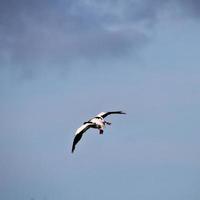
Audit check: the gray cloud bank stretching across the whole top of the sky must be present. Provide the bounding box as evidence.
[0,0,200,72]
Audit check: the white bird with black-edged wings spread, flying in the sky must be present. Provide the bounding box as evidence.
[72,111,126,153]
